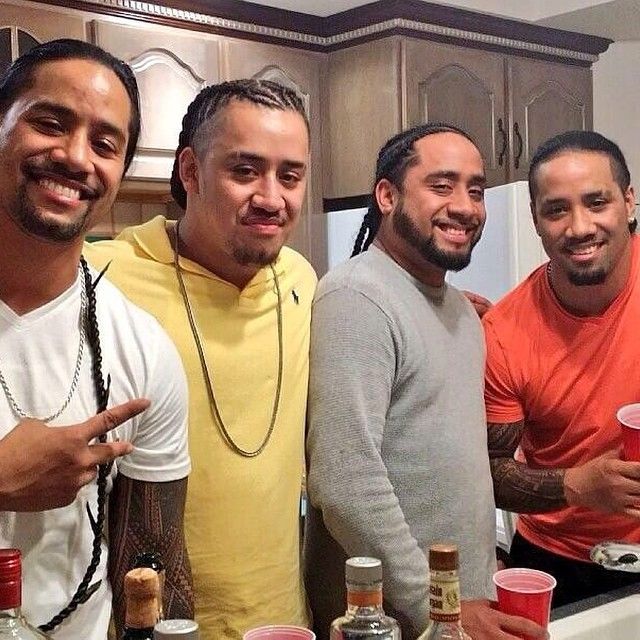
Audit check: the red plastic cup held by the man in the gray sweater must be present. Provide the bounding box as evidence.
[493,569,556,640]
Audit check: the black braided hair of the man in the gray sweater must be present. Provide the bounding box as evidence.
[351,122,476,258]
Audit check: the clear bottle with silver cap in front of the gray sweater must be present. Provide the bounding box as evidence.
[330,558,402,640]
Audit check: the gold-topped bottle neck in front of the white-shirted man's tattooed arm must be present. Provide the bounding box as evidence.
[122,567,160,640]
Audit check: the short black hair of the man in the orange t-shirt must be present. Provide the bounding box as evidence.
[529,131,631,202]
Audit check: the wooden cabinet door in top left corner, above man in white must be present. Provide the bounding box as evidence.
[0,3,86,75]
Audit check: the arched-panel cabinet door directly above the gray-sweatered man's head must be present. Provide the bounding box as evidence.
[404,38,508,186]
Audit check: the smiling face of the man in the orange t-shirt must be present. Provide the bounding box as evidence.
[532,151,635,286]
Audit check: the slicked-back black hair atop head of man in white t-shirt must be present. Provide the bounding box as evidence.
[0,38,140,173]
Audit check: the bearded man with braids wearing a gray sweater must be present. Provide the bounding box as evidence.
[305,124,545,640]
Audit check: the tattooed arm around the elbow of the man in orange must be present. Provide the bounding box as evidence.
[488,420,567,513]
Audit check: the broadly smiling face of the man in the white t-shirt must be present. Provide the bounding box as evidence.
[0,59,131,242]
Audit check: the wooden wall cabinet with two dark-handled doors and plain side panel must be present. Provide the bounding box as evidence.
[325,38,593,199]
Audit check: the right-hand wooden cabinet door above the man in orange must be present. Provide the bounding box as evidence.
[507,57,593,181]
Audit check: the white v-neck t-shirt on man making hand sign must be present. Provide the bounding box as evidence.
[0,272,190,640]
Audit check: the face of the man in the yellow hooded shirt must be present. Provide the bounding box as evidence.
[180,100,309,283]
